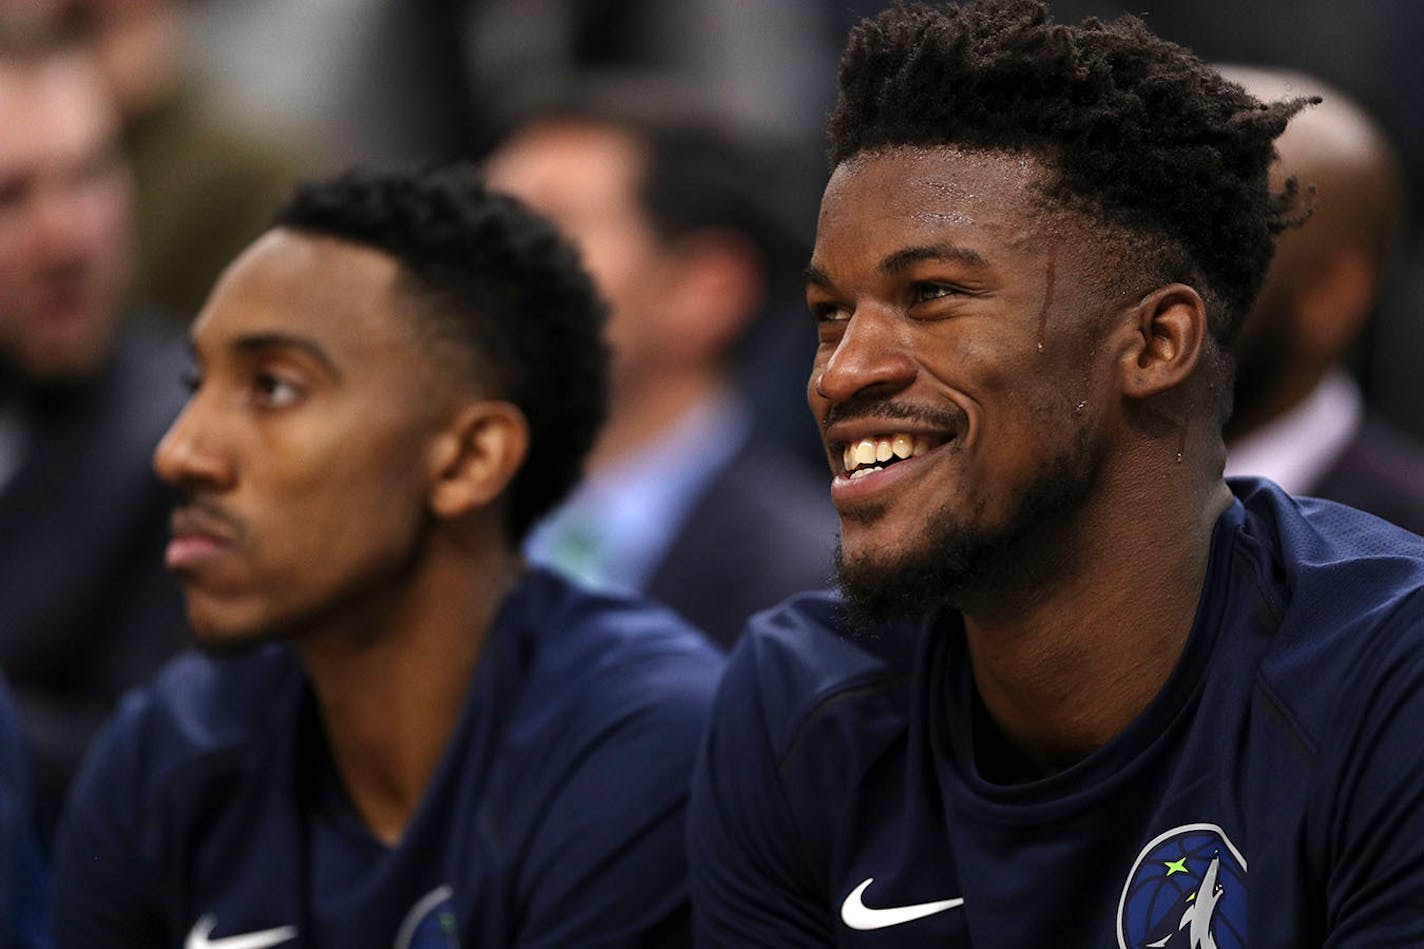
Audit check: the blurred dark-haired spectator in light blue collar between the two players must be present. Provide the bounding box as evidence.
[488,80,834,644]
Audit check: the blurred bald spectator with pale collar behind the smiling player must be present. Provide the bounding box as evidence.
[1222,67,1424,533]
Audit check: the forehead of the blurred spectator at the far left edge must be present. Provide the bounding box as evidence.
[0,53,118,168]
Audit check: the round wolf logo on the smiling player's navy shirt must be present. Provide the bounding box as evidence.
[1118,824,1246,949]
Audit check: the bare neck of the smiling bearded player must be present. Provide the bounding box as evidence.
[963,449,1230,775]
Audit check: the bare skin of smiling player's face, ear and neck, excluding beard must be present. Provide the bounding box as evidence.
[807,148,1230,774]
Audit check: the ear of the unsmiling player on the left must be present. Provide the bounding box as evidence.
[429,402,530,519]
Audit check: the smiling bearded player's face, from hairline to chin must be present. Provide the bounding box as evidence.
[806,148,1111,609]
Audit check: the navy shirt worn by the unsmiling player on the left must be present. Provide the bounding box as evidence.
[54,571,722,949]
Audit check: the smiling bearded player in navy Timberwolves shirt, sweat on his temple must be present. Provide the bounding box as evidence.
[689,0,1424,949]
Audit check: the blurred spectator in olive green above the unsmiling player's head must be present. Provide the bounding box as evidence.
[67,0,303,319]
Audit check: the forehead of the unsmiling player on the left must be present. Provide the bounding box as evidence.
[192,229,414,361]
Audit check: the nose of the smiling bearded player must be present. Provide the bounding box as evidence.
[812,305,916,403]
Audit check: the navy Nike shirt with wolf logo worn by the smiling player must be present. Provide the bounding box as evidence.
[689,480,1424,949]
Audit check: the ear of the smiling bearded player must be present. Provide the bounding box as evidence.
[1118,284,1208,399]
